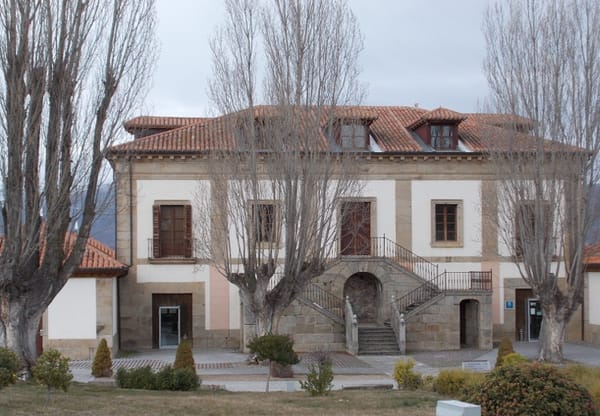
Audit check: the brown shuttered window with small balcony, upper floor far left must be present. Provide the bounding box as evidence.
[151,204,192,258]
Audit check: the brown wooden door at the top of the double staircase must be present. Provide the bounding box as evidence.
[340,201,371,256]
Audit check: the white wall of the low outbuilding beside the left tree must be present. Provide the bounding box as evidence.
[48,278,96,339]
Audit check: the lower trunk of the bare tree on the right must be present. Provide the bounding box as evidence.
[538,308,569,363]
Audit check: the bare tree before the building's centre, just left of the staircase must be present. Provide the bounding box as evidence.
[198,0,367,337]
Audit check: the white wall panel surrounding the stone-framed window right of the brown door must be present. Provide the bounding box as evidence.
[411,180,482,257]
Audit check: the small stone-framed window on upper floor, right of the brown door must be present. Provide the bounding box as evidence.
[431,200,463,247]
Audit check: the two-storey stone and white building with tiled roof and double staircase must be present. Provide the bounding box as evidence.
[108,107,581,352]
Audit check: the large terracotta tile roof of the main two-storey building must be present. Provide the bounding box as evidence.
[109,106,564,156]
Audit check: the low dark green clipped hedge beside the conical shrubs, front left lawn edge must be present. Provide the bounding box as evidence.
[116,366,200,391]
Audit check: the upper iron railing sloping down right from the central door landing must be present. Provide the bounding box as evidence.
[371,235,439,282]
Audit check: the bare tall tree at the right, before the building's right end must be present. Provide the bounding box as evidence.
[484,0,600,362]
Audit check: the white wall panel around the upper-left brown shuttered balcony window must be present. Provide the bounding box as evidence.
[136,179,210,259]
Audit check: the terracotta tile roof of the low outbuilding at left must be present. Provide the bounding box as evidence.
[0,233,128,277]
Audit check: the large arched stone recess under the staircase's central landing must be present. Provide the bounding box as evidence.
[344,273,381,323]
